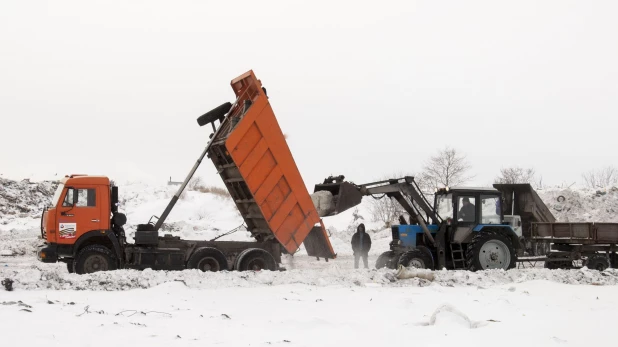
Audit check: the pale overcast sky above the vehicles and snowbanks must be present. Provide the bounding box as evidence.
[0,0,618,191]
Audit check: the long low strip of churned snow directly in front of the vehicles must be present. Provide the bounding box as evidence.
[0,260,618,291]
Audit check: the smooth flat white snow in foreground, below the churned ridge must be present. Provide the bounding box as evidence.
[0,270,618,346]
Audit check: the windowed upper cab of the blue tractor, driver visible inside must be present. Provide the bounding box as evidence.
[434,187,504,227]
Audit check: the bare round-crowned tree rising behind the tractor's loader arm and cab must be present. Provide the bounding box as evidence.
[421,147,474,191]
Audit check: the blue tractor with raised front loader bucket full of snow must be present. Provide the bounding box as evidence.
[314,176,521,271]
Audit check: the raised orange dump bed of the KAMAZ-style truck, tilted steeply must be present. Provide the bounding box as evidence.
[208,71,335,259]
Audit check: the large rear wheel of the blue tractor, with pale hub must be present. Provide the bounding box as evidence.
[466,231,517,271]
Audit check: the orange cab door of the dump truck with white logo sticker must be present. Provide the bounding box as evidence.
[56,186,105,244]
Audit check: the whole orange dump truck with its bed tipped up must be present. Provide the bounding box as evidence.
[38,71,335,274]
